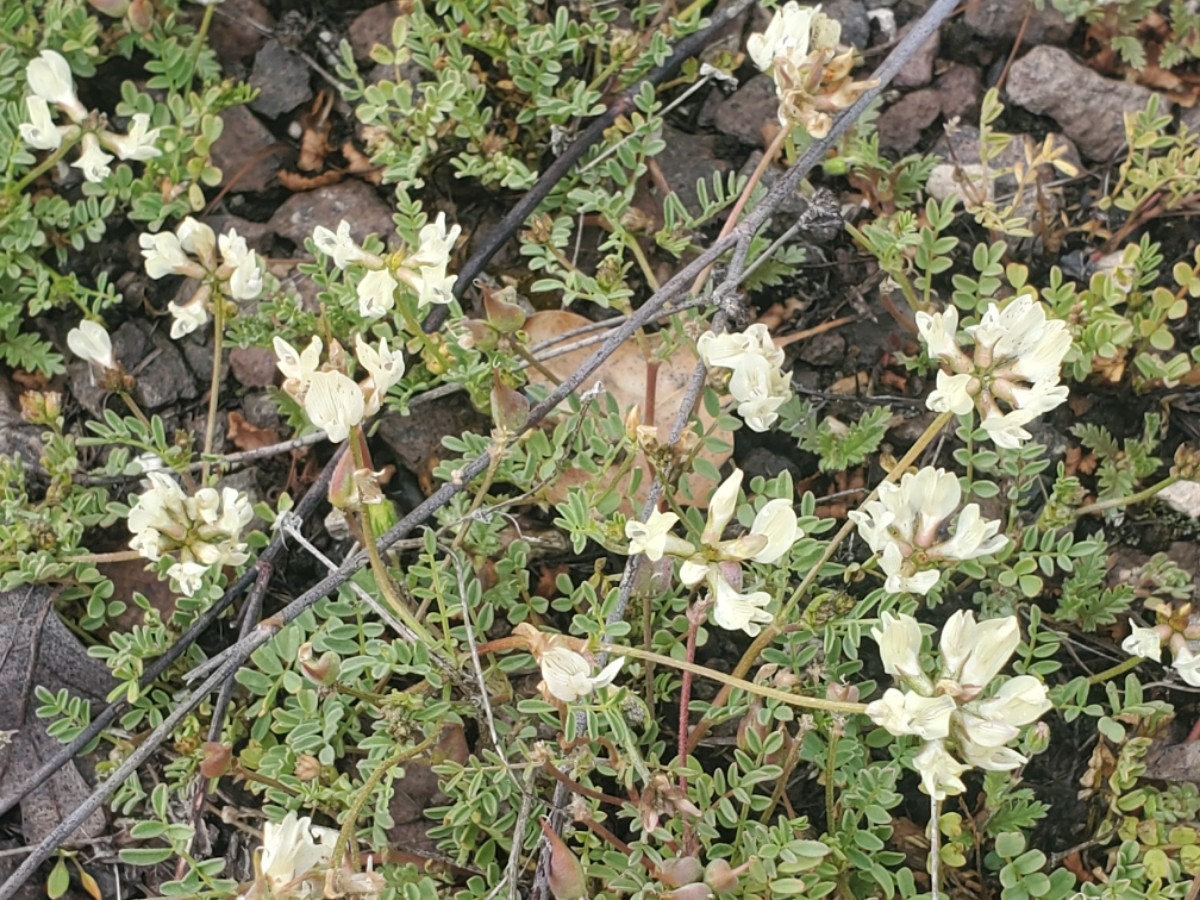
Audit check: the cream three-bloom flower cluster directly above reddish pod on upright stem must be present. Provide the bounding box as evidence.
[275,335,404,443]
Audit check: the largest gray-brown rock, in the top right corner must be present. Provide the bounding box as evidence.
[1008,46,1171,161]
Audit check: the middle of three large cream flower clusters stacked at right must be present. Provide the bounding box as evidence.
[850,466,1008,594]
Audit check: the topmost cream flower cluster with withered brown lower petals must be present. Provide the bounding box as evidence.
[746,0,875,138]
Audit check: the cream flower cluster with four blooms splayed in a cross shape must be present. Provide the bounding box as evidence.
[625,469,803,636]
